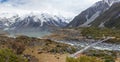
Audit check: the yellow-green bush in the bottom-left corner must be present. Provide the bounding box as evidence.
[0,49,28,62]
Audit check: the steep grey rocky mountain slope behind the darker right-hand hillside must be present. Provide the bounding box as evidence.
[67,0,120,27]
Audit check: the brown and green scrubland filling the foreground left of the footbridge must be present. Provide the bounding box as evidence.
[0,36,77,62]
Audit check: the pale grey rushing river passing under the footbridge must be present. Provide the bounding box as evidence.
[57,40,120,51]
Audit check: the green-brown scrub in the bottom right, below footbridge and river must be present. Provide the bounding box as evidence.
[66,50,120,62]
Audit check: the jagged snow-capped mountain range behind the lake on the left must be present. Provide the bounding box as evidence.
[0,13,70,31]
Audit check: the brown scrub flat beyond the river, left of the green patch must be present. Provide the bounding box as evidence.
[44,29,81,41]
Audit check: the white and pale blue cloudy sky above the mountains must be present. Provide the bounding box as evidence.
[0,0,99,17]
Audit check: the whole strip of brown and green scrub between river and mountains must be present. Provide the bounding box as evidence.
[44,27,120,44]
